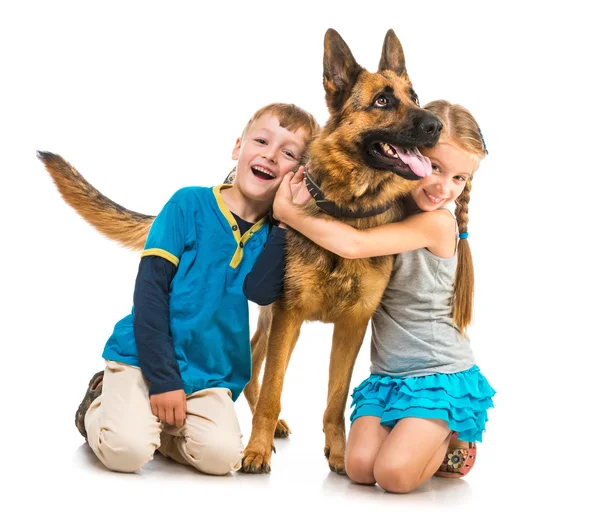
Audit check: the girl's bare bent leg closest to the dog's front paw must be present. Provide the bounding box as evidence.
[346,416,392,484]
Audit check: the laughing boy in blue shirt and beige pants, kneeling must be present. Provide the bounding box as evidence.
[76,104,318,475]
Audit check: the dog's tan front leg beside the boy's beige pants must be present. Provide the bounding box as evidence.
[241,304,303,473]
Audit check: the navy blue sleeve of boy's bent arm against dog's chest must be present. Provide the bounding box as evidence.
[244,226,286,305]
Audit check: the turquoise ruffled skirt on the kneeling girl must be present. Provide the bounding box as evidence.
[350,366,496,442]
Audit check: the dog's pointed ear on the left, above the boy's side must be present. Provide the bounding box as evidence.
[323,28,364,113]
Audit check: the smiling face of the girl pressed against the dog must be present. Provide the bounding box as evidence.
[411,142,477,211]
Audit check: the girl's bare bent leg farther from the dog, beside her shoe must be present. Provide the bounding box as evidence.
[373,417,451,493]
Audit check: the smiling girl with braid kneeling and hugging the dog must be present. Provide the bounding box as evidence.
[274,100,495,493]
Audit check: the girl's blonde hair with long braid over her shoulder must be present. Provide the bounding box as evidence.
[425,100,487,334]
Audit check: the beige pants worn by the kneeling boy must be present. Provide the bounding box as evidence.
[85,361,244,475]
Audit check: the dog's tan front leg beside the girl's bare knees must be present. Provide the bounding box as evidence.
[323,317,369,475]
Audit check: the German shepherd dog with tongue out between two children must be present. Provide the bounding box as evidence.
[38,29,442,474]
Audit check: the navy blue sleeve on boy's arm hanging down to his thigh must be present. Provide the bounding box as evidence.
[133,256,183,395]
